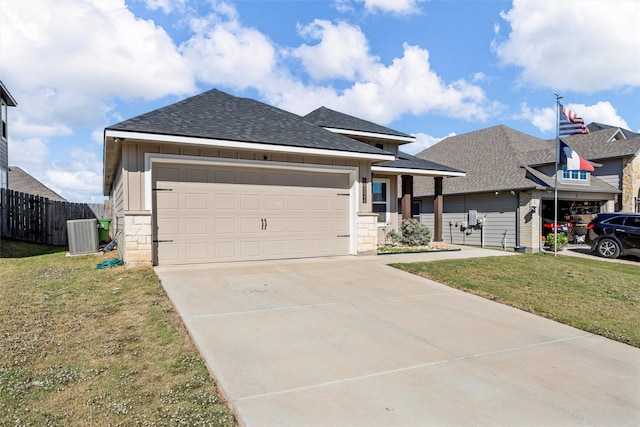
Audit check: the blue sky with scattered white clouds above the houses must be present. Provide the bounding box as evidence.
[0,0,640,202]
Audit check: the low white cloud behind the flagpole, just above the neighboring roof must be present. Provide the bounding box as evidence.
[514,101,629,132]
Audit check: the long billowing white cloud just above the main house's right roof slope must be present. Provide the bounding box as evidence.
[274,37,501,124]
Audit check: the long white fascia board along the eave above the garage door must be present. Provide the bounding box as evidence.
[105,129,395,161]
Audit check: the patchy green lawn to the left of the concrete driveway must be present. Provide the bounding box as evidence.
[0,239,235,426]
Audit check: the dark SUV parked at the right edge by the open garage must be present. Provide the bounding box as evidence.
[585,212,640,258]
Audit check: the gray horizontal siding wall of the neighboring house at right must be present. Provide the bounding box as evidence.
[412,193,517,249]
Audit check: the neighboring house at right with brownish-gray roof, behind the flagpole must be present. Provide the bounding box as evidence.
[414,125,640,252]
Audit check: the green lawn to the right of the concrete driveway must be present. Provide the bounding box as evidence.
[392,254,640,347]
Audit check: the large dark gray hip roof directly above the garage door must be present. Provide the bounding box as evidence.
[106,89,390,155]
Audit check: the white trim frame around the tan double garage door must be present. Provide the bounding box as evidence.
[144,153,360,255]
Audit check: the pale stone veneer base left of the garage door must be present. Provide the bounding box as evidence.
[121,211,152,267]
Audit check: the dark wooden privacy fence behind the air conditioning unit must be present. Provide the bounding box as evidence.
[0,189,104,246]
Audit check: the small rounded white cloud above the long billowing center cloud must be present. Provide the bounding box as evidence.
[291,19,378,80]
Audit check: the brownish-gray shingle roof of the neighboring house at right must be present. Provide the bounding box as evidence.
[414,125,624,196]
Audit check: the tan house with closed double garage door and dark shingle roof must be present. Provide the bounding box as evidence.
[104,90,464,265]
